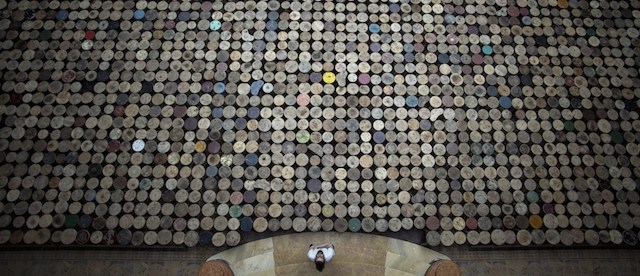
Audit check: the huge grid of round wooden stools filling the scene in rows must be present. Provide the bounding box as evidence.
[0,0,640,246]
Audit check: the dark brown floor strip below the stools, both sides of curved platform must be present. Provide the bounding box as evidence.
[0,236,640,275]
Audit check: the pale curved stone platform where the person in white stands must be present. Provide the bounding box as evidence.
[209,232,450,276]
